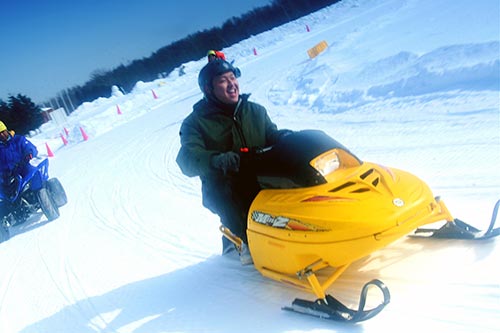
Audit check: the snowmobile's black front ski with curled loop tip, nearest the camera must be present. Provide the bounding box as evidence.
[282,279,391,323]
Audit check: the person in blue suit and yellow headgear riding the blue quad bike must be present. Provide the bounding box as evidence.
[0,121,38,204]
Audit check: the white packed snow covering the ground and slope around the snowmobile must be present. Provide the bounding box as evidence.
[0,0,500,333]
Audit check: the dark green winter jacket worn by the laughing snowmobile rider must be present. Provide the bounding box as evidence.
[176,95,279,208]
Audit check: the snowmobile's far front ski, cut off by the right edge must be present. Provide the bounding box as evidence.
[410,200,500,240]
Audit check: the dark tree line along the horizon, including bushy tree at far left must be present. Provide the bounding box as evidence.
[0,0,341,133]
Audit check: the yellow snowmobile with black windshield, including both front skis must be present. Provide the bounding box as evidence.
[221,130,500,322]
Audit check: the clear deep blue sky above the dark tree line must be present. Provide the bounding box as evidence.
[0,0,271,103]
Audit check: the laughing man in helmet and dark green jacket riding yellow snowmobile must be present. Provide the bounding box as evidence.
[177,59,286,264]
